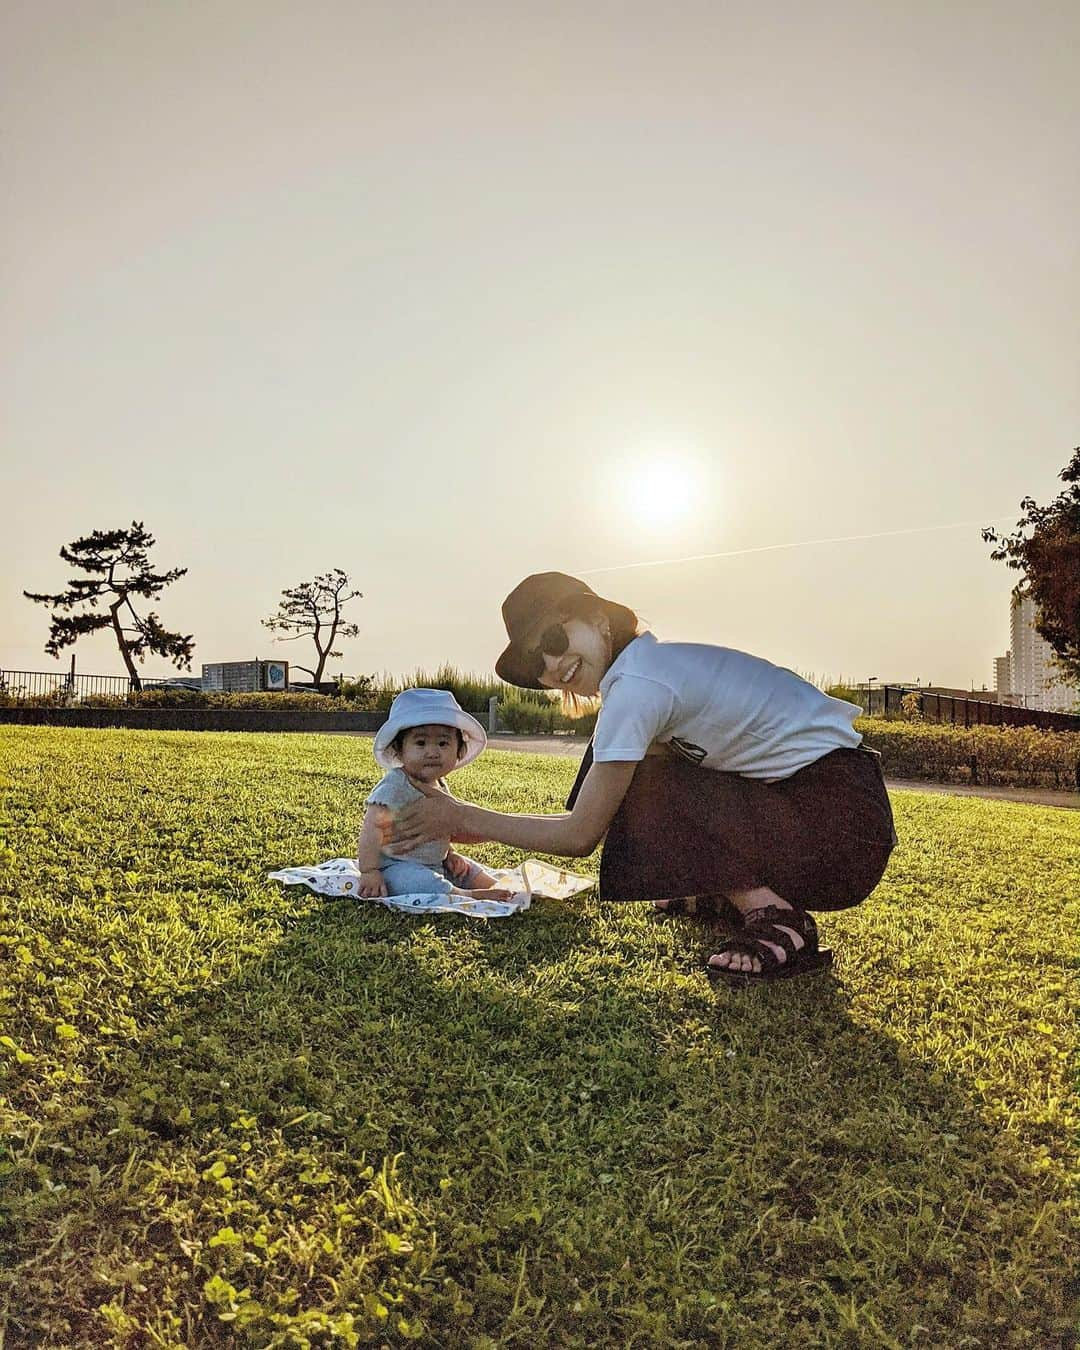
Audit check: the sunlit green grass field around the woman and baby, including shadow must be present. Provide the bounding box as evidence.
[0,728,1080,1350]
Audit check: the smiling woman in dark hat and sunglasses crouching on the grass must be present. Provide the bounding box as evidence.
[394,572,896,984]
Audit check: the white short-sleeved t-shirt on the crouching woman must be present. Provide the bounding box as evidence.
[593,633,863,782]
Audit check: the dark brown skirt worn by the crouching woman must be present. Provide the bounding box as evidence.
[567,747,896,910]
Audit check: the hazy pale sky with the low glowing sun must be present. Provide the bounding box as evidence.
[0,0,1080,689]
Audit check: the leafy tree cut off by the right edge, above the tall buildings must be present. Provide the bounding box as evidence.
[983,446,1080,683]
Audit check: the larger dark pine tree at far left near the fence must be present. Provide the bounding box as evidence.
[23,520,194,689]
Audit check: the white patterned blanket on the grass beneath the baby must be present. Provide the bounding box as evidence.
[267,857,597,919]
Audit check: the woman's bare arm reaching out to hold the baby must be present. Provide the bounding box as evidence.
[394,760,637,857]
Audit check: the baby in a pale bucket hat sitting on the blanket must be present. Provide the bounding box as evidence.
[356,689,512,900]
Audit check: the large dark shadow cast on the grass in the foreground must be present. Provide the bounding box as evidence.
[4,902,1076,1347]
